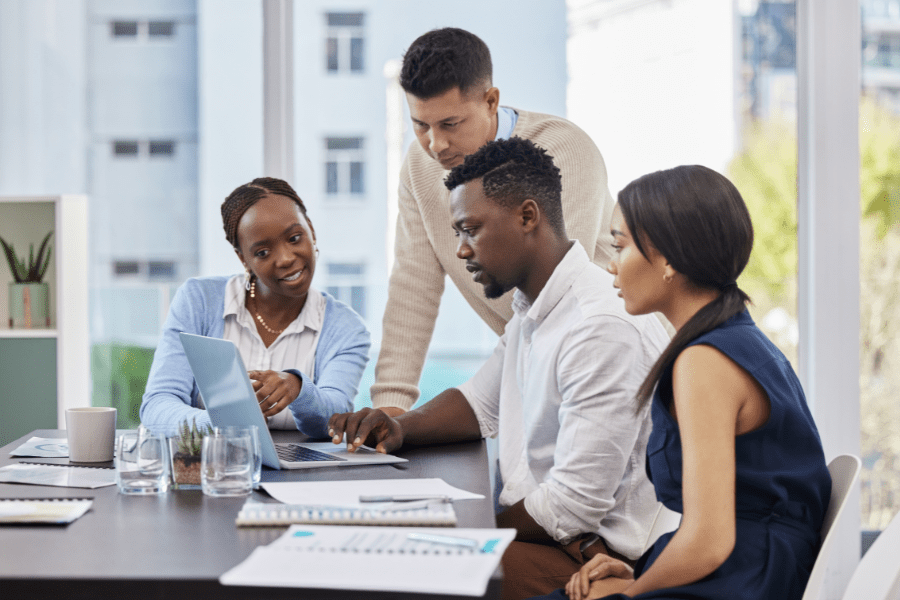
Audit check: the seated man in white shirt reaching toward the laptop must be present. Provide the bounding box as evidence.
[329,137,668,598]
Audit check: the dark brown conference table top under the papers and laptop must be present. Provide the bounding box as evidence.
[0,429,502,600]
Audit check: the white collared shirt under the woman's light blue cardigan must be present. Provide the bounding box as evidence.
[222,275,325,429]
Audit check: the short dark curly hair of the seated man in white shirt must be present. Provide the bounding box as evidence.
[444,137,566,235]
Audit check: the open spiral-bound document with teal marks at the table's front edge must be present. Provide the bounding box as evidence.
[219,525,516,596]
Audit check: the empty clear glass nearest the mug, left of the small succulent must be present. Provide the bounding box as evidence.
[115,425,169,494]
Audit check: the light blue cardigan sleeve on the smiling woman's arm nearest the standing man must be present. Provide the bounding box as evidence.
[287,293,371,438]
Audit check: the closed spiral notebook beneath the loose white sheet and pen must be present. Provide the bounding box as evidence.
[235,500,456,527]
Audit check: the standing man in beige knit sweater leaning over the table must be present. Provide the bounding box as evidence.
[371,28,615,415]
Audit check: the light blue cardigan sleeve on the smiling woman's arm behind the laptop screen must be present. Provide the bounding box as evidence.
[141,278,227,436]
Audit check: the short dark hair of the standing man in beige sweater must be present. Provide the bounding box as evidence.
[400,27,493,99]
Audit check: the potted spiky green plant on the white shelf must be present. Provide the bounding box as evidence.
[0,231,53,329]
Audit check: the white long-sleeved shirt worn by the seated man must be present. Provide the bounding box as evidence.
[459,241,669,558]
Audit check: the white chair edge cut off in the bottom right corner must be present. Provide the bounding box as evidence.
[844,506,900,600]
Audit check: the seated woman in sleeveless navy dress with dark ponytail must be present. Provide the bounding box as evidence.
[540,166,831,600]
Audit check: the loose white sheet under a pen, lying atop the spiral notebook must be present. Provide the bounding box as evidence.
[260,478,484,508]
